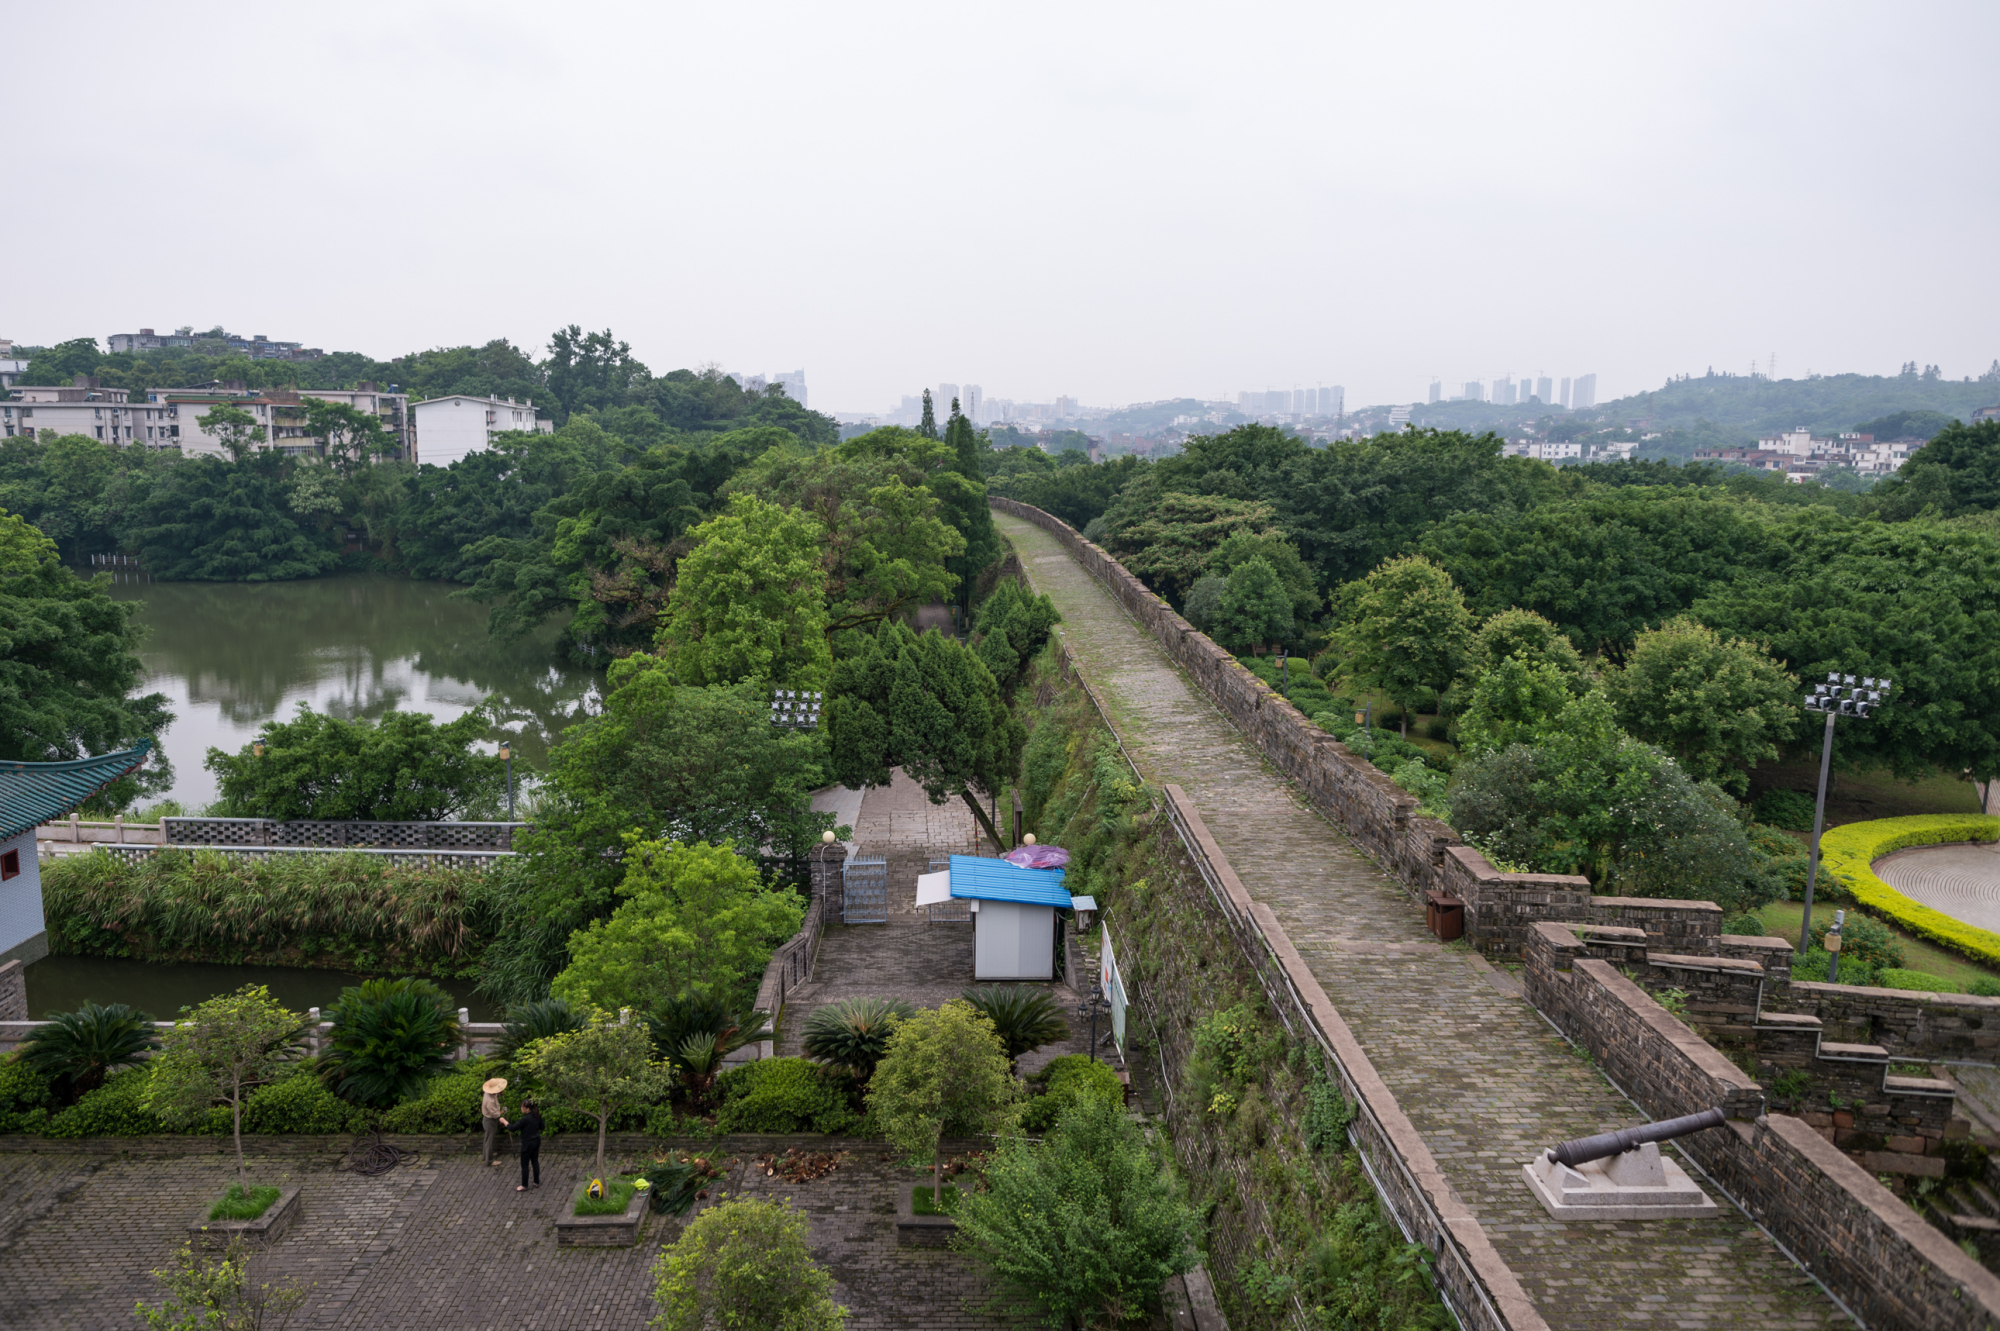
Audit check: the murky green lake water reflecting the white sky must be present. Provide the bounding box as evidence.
[101,570,602,811]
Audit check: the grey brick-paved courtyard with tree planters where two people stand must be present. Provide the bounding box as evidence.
[0,1139,1016,1331]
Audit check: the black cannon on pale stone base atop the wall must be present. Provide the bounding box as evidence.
[1522,1109,1728,1221]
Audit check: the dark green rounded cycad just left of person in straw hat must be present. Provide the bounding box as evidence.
[320,979,458,1107]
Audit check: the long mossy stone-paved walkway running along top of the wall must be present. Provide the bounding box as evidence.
[994,512,1850,1331]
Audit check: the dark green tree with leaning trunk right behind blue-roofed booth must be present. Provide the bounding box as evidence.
[826,624,1028,845]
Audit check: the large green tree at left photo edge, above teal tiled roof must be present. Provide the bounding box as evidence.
[0,510,174,787]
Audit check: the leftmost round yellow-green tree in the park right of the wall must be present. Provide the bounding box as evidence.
[1340,556,1472,739]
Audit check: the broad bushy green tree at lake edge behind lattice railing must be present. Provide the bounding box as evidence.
[204,703,506,821]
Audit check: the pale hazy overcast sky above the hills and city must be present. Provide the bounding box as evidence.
[15,0,2000,410]
